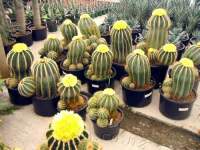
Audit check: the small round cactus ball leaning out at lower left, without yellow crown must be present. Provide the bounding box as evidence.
[18,77,36,97]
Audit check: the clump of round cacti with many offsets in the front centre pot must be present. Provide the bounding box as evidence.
[87,88,120,128]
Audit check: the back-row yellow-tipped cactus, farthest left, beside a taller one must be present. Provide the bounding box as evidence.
[60,19,78,47]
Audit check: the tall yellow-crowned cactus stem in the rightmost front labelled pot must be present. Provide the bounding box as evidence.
[172,58,195,99]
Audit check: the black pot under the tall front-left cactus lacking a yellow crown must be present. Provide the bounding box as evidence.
[32,96,59,116]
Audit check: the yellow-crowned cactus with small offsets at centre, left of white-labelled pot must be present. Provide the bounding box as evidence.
[87,44,113,80]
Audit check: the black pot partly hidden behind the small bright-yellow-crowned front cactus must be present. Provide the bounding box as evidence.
[60,61,87,84]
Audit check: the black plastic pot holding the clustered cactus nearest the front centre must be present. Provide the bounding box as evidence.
[92,109,124,140]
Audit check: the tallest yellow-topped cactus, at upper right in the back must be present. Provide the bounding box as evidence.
[146,8,171,49]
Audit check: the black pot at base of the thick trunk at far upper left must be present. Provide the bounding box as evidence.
[13,29,33,46]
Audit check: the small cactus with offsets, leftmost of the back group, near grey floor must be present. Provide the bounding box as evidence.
[39,34,62,61]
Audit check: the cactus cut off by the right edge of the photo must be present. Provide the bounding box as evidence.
[182,43,200,66]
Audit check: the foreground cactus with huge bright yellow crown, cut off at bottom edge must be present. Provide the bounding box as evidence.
[46,111,89,150]
